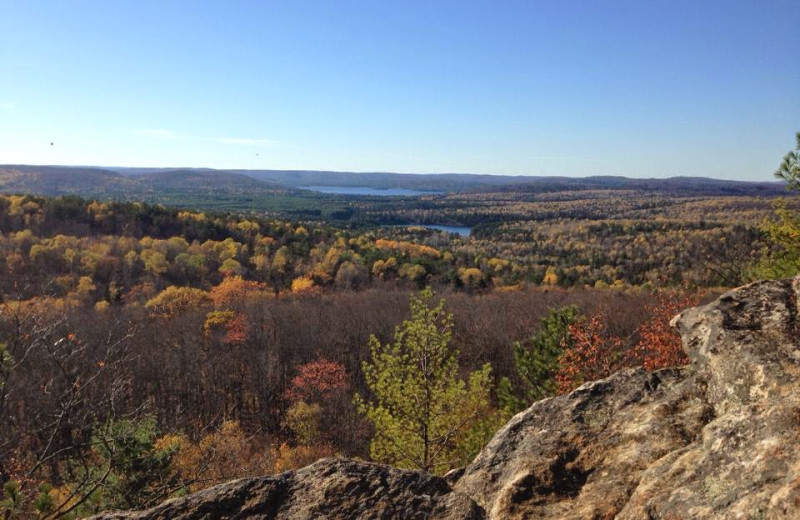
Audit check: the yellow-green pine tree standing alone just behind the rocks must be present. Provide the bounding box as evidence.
[356,289,498,474]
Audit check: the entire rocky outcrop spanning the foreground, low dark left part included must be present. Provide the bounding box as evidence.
[90,279,800,520]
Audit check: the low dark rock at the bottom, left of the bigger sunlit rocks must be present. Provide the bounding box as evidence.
[93,459,484,520]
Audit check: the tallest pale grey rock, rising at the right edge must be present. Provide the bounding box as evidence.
[619,279,800,519]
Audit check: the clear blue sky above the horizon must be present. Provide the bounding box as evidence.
[0,0,800,180]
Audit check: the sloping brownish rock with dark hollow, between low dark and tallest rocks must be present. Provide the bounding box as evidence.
[455,369,712,518]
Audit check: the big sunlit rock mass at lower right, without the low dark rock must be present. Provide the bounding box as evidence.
[455,281,800,520]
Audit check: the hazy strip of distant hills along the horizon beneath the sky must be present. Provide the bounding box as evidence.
[0,165,785,210]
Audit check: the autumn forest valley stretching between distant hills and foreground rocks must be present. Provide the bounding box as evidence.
[0,135,800,518]
